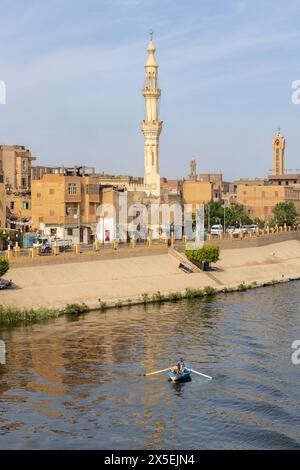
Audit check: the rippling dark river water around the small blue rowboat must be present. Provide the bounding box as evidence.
[0,282,300,450]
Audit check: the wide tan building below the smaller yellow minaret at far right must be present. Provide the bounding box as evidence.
[237,185,300,220]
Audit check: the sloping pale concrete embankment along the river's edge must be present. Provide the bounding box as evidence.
[0,240,300,309]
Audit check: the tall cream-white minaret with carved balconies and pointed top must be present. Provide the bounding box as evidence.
[141,33,162,197]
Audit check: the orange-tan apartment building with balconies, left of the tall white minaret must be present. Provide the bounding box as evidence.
[31,172,101,243]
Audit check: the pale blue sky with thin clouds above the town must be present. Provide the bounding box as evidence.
[0,0,300,179]
